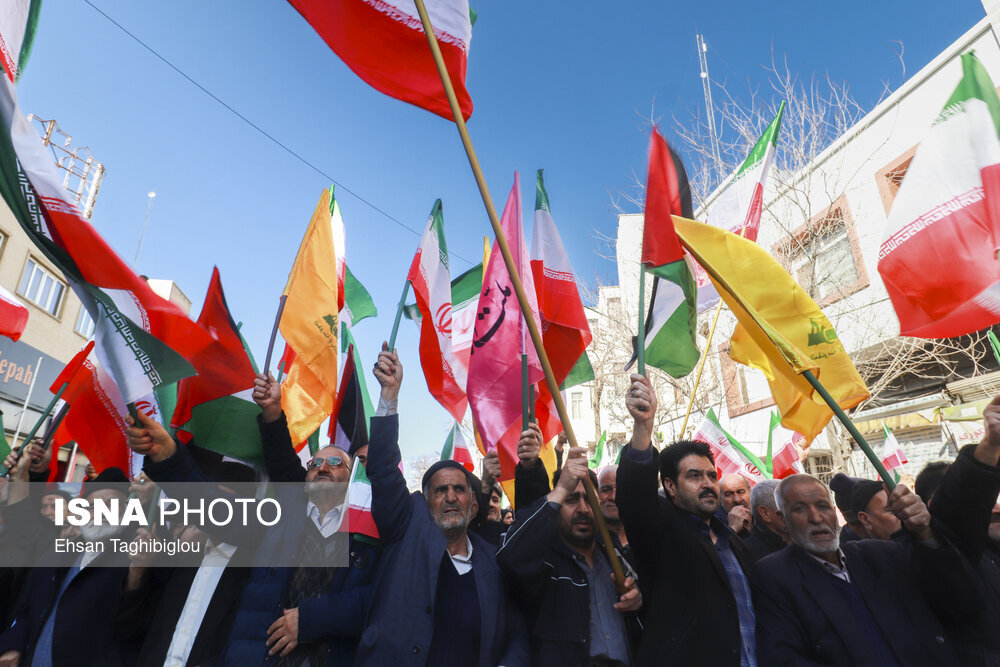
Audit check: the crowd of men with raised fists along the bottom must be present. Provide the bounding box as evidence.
[0,346,1000,667]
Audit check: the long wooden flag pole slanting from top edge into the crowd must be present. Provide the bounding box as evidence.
[414,0,625,595]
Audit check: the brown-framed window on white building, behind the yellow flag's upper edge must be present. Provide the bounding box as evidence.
[776,197,868,306]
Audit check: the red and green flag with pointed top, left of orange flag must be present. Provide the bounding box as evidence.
[170,269,264,466]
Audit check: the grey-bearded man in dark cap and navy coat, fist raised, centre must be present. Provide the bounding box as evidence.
[357,345,528,667]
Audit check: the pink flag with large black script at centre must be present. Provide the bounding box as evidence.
[468,172,543,479]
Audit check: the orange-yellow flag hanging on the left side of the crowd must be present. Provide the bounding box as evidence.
[280,190,337,445]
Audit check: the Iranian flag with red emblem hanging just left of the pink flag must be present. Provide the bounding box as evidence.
[406,199,469,421]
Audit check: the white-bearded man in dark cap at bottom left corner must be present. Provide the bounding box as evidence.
[0,468,128,667]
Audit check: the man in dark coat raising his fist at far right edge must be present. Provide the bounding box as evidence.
[915,397,1000,665]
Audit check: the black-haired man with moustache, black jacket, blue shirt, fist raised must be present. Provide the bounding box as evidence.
[616,375,757,667]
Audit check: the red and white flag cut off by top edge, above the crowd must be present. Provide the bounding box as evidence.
[289,0,472,120]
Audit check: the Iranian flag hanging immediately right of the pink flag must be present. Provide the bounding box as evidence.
[531,169,593,442]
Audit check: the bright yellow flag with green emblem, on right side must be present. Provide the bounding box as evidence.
[674,216,870,442]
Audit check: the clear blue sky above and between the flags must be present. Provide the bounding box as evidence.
[13,0,983,458]
